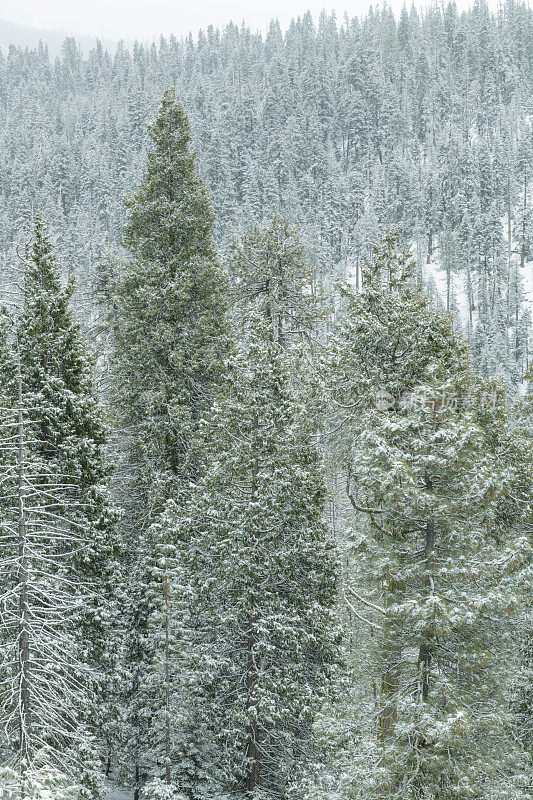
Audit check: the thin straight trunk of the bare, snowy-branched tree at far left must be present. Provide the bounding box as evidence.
[17,356,32,784]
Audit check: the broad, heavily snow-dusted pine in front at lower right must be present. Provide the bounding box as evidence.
[347,372,528,798]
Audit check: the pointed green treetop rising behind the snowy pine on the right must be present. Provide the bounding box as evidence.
[333,232,467,407]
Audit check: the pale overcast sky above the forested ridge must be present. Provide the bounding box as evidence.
[0,0,494,39]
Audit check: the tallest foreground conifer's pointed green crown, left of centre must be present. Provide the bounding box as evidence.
[112,89,227,503]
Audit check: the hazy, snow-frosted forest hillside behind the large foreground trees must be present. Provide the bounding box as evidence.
[0,2,533,386]
